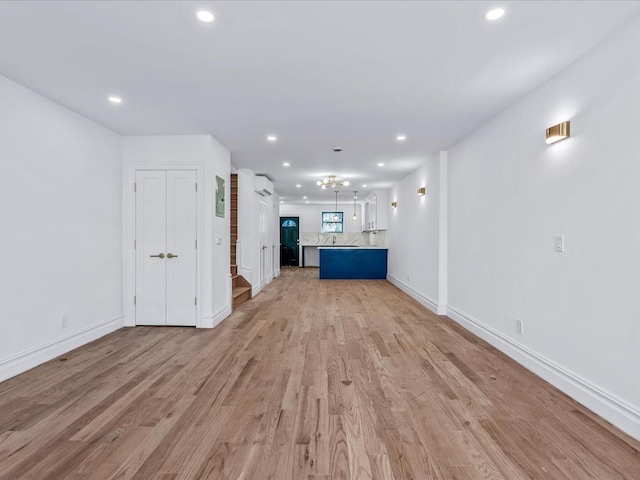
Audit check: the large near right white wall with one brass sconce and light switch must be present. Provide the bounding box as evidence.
[449,18,640,438]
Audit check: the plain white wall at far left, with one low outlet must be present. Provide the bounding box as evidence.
[0,76,123,380]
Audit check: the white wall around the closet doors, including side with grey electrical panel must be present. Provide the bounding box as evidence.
[123,135,231,327]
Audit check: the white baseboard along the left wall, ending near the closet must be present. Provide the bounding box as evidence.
[0,315,124,382]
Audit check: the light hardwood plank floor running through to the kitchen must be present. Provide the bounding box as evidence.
[0,269,640,480]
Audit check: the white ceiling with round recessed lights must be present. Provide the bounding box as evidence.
[0,0,640,203]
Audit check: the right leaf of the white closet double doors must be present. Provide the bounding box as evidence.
[166,171,197,326]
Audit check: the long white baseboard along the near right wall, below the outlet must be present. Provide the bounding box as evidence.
[447,305,640,440]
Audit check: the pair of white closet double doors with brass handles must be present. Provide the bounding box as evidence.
[134,170,197,326]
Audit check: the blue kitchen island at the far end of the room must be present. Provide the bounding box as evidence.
[318,247,388,280]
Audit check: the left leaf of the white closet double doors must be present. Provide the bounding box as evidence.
[136,171,167,325]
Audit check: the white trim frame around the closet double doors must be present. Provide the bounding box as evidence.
[124,164,204,328]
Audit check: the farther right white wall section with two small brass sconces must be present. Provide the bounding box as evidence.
[387,156,440,311]
